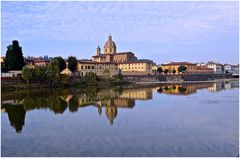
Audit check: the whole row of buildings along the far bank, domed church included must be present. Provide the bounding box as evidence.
[1,35,239,76]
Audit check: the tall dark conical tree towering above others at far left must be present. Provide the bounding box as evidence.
[4,40,25,70]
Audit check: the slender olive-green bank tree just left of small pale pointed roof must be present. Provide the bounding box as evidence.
[48,59,60,87]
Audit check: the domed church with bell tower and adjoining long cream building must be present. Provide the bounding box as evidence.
[77,35,153,76]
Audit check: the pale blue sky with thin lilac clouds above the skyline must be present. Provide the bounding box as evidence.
[1,1,239,64]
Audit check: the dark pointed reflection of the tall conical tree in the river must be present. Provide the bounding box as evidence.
[5,105,26,133]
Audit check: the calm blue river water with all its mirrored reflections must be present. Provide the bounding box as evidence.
[1,81,239,157]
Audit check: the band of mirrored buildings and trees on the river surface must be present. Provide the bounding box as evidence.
[1,81,239,133]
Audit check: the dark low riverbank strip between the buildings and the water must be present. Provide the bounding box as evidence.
[1,76,239,92]
